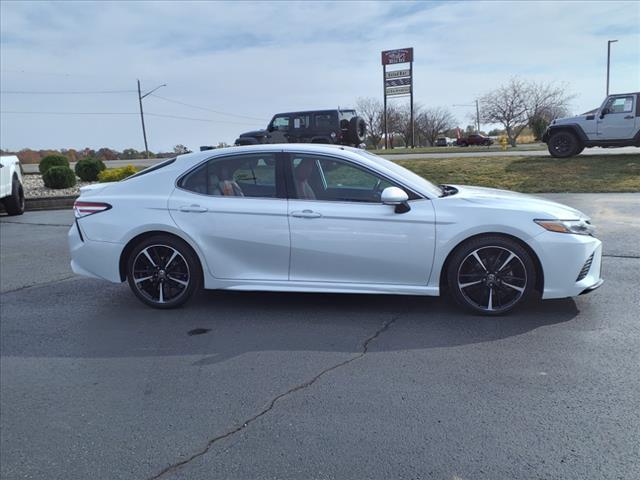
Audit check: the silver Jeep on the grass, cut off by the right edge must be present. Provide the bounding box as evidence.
[542,92,640,158]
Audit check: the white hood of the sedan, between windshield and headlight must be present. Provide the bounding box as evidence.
[445,185,589,220]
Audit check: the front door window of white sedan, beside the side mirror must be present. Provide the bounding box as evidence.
[291,154,395,203]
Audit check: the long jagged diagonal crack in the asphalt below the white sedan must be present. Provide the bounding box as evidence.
[149,315,401,480]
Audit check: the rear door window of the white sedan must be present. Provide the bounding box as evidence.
[178,153,277,198]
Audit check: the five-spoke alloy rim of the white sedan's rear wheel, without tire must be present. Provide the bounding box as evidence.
[132,245,191,304]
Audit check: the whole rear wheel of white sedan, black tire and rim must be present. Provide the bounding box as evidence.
[127,235,202,309]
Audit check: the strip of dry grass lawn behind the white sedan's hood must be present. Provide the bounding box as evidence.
[397,153,640,193]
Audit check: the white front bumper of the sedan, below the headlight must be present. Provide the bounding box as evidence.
[531,232,603,299]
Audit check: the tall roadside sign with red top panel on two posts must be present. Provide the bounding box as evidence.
[382,48,415,149]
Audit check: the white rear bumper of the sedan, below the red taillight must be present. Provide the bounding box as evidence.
[67,223,124,283]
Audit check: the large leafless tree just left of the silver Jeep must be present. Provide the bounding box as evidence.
[480,78,572,147]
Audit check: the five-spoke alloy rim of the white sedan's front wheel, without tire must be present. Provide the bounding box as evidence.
[457,246,527,313]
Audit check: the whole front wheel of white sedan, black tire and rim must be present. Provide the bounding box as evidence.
[446,235,536,316]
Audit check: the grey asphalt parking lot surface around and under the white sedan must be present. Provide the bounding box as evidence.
[0,194,640,480]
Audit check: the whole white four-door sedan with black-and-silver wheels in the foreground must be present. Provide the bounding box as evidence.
[69,144,602,315]
